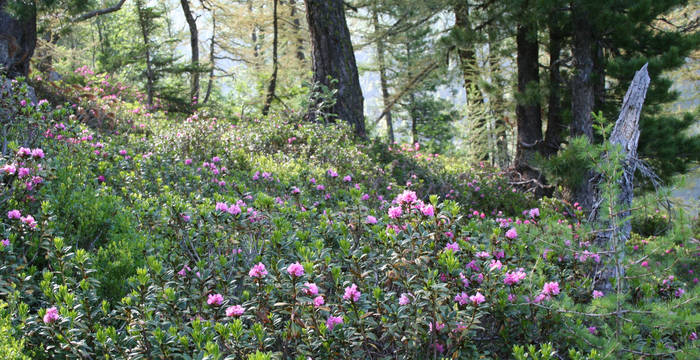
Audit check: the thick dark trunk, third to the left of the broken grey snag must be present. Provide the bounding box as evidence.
[515,23,542,188]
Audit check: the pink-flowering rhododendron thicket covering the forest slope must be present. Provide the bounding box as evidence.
[0,79,700,359]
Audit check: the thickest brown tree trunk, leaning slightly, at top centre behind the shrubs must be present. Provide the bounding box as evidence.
[304,0,365,137]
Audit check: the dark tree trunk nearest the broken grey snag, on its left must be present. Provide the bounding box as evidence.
[571,1,595,210]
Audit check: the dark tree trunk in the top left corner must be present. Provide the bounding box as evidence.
[0,0,36,78]
